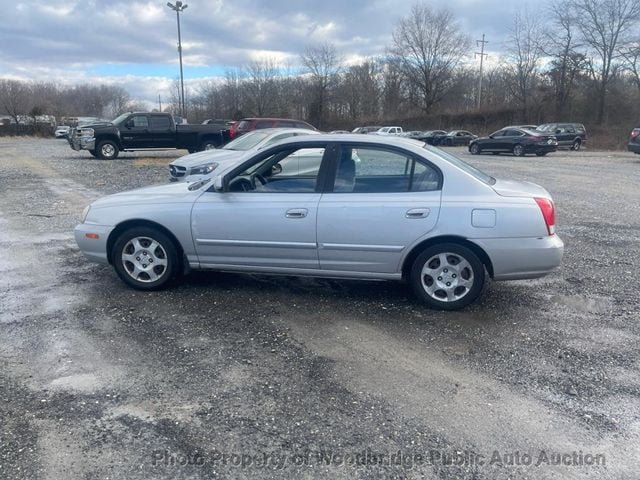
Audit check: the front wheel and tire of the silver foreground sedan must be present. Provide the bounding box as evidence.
[111,227,180,290]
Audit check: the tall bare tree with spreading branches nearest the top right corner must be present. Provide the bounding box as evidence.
[572,0,640,124]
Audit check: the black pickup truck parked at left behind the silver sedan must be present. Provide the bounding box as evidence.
[68,112,229,160]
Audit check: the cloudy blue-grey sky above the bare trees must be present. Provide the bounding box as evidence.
[0,0,522,102]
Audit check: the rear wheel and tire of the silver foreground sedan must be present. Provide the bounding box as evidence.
[410,243,485,310]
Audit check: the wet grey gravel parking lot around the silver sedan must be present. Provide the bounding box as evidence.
[0,138,640,480]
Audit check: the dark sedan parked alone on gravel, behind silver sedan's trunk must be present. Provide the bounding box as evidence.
[469,128,558,157]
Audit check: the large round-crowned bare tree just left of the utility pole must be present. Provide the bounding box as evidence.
[390,3,470,113]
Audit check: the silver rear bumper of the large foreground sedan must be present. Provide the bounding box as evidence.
[471,235,564,280]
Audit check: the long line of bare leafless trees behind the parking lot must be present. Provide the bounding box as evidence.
[0,0,640,139]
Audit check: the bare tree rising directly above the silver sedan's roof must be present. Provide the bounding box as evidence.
[301,43,342,128]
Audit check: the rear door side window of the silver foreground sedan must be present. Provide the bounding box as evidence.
[333,146,440,193]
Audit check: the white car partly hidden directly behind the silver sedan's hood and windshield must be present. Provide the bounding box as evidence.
[169,128,320,182]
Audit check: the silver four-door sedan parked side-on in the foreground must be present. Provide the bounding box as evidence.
[75,135,563,310]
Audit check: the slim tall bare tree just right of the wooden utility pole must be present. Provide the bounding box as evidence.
[504,11,545,122]
